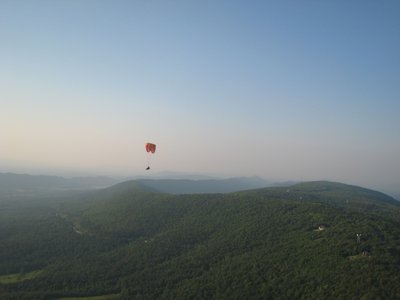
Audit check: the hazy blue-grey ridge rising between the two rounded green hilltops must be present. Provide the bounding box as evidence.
[137,176,272,194]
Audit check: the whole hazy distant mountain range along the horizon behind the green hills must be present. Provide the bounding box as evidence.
[0,173,282,196]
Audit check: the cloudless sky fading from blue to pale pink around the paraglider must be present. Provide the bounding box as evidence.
[0,0,400,190]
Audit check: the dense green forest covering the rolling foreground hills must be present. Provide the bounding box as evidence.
[0,181,400,299]
